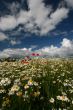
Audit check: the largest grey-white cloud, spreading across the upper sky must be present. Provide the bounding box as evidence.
[0,0,69,35]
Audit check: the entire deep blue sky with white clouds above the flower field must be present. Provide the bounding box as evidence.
[0,0,73,58]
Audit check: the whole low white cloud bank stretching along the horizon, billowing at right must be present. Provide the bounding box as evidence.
[0,38,73,58]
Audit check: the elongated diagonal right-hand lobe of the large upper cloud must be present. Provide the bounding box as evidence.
[41,7,69,34]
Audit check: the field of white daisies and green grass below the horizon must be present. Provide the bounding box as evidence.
[0,58,73,110]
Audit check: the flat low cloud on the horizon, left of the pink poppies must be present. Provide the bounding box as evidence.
[0,48,31,58]
